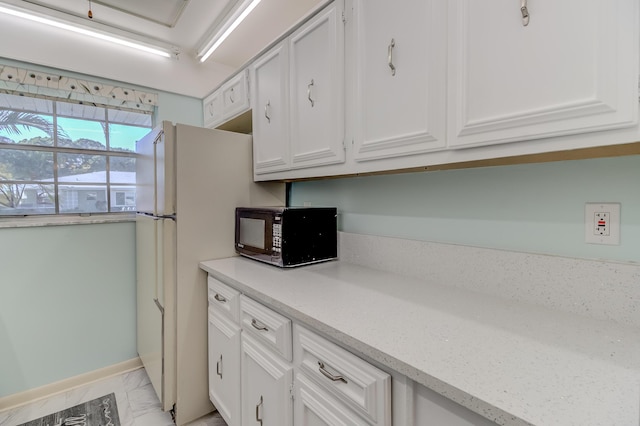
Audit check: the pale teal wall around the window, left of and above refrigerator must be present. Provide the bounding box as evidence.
[0,59,203,400]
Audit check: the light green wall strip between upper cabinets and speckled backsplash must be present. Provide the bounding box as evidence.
[291,156,640,262]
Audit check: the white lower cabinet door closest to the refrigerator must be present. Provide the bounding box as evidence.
[209,309,240,425]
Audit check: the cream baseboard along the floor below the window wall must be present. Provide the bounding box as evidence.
[0,357,142,412]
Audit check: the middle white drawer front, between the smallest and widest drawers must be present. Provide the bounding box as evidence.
[240,295,292,361]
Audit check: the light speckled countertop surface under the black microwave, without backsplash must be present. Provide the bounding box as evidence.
[200,257,640,426]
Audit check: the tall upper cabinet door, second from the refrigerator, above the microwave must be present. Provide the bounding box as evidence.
[289,0,345,168]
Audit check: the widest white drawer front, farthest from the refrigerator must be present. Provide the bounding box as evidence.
[293,324,391,425]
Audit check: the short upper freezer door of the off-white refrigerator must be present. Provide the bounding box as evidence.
[136,122,176,216]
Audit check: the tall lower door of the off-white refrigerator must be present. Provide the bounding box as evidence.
[136,214,175,410]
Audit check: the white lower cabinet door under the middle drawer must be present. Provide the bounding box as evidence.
[242,333,293,426]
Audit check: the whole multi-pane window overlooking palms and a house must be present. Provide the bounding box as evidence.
[0,94,151,216]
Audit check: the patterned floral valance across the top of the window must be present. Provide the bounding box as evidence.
[0,64,158,112]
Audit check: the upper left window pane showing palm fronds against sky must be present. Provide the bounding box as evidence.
[0,109,53,146]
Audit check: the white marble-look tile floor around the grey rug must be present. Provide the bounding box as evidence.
[0,368,227,426]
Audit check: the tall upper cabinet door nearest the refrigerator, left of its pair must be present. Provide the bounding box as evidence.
[251,43,290,174]
